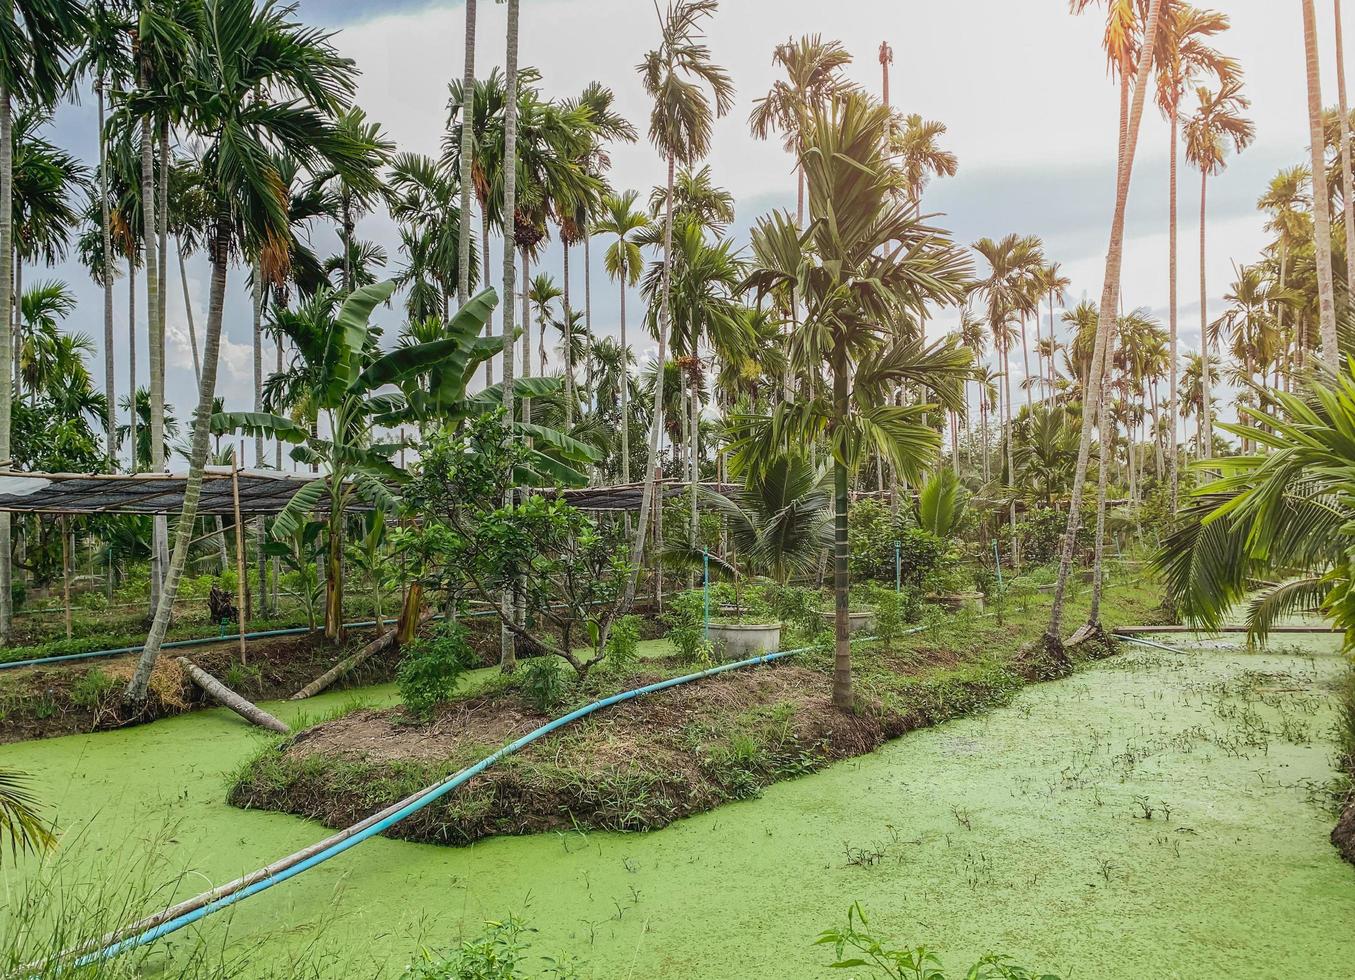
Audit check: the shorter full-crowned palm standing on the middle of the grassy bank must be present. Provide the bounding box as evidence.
[733,94,970,709]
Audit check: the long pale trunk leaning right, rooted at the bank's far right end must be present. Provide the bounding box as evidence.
[1043,0,1163,655]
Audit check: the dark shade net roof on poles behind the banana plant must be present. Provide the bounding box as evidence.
[0,466,737,516]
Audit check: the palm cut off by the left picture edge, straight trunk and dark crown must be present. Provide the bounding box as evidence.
[0,0,83,642]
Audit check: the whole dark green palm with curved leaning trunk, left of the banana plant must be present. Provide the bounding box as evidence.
[127,0,374,702]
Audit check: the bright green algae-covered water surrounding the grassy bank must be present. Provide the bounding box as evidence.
[0,637,1355,979]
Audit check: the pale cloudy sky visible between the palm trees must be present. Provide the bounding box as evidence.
[39,0,1336,460]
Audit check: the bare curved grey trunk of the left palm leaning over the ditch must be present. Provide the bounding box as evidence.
[126,212,234,702]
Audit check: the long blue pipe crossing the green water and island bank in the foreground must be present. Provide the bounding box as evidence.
[75,626,888,968]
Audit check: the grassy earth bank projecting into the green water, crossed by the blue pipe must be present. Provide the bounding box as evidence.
[229,581,1156,844]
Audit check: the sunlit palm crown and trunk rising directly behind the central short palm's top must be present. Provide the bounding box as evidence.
[748,34,855,226]
